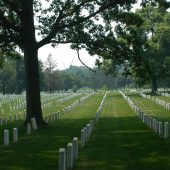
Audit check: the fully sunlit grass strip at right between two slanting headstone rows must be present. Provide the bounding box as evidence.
[126,93,170,122]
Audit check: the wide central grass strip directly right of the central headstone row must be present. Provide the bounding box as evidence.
[74,94,170,170]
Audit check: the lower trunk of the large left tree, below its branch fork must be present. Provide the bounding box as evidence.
[24,47,45,125]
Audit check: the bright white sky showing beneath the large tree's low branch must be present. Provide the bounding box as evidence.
[38,2,140,70]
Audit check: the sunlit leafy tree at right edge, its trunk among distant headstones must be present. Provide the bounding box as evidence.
[127,5,170,94]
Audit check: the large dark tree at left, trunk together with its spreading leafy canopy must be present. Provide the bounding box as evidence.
[0,0,167,124]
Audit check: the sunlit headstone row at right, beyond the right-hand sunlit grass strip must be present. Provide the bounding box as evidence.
[139,92,170,110]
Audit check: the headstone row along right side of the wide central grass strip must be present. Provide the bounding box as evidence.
[120,91,169,138]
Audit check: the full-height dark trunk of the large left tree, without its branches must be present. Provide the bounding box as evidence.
[21,0,46,125]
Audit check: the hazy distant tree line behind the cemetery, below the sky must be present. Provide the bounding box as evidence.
[0,55,132,94]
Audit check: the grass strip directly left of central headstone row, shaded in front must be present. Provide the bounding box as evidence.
[0,94,104,170]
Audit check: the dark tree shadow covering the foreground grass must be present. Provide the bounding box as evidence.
[0,116,170,170]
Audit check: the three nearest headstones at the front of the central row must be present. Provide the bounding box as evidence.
[59,137,78,170]
